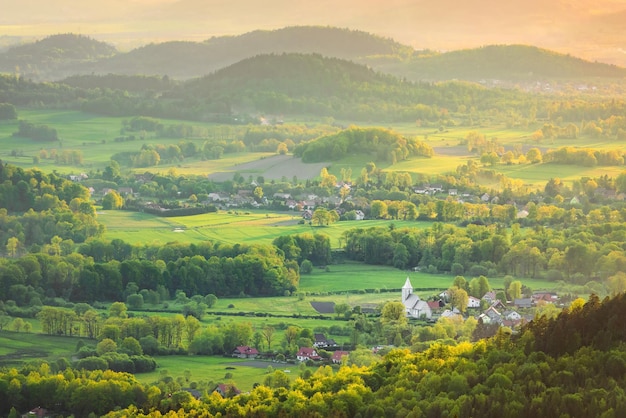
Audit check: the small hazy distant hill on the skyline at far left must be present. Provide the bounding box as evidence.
[0,34,117,80]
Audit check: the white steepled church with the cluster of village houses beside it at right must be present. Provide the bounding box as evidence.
[402,277,559,328]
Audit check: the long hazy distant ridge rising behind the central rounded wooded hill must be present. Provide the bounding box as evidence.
[90,26,413,79]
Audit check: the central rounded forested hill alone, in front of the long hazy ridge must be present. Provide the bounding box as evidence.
[171,54,524,121]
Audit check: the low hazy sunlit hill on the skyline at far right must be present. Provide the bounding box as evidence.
[389,45,626,80]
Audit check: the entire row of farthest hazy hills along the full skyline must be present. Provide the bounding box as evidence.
[0,26,626,85]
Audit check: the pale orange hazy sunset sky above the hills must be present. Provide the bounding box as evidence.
[0,0,626,66]
